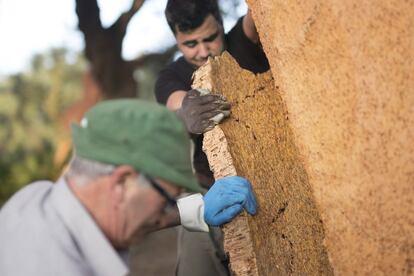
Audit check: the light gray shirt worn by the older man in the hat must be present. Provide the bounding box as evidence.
[0,178,128,276]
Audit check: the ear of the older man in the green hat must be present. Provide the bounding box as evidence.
[109,165,137,204]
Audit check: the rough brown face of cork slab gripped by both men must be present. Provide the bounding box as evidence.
[194,53,332,275]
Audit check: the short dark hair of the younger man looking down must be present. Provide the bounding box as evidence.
[165,0,223,34]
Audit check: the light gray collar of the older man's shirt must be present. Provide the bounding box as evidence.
[51,177,129,275]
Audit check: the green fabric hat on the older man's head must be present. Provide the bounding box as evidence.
[72,99,201,192]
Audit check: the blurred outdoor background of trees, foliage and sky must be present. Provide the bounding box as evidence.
[0,0,247,206]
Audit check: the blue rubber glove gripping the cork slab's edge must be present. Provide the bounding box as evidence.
[204,176,257,226]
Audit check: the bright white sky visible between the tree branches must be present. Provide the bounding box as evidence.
[0,0,247,77]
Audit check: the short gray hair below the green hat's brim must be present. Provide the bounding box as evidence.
[66,155,116,186]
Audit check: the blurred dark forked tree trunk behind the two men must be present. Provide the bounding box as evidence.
[76,0,144,99]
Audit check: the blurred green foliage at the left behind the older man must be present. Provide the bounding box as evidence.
[0,49,85,206]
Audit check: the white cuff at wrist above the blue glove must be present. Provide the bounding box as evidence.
[177,194,209,232]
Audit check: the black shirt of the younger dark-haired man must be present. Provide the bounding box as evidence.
[155,18,269,187]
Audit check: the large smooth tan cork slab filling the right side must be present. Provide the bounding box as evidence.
[247,0,414,275]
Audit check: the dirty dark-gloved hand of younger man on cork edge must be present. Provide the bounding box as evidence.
[177,89,230,134]
